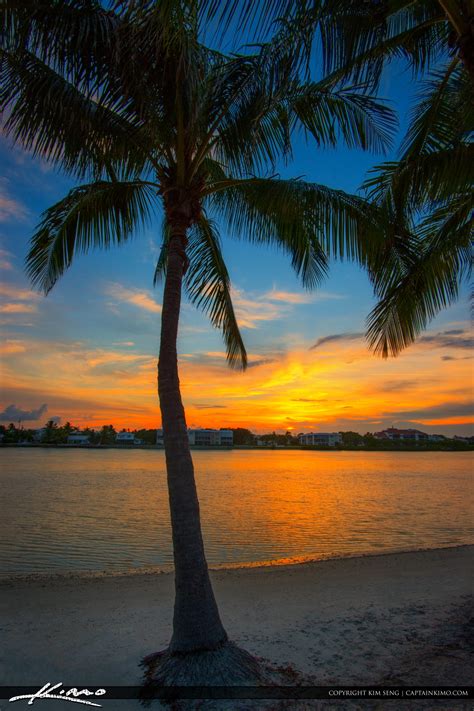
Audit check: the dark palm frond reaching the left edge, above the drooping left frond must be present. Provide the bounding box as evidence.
[0,50,147,177]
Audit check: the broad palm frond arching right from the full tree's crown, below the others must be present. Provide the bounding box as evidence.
[209,178,380,288]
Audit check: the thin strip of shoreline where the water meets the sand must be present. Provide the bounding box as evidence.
[0,541,474,589]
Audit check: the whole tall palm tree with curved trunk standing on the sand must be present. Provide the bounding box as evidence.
[1,0,394,683]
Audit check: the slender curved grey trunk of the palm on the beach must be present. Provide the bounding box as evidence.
[158,223,227,653]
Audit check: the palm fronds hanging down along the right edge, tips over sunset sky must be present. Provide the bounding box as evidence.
[365,62,474,357]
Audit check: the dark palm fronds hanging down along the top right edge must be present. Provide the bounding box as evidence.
[207,0,474,84]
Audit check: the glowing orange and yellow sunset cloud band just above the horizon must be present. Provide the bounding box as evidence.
[2,324,472,432]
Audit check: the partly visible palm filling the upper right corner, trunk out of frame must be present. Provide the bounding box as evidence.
[209,0,474,357]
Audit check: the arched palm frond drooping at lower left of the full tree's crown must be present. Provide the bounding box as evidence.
[26,181,156,293]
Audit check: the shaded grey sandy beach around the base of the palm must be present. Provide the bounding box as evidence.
[0,546,474,710]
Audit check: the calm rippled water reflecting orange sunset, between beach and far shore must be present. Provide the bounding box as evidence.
[0,449,474,573]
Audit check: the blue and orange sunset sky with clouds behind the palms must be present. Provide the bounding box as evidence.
[0,54,473,436]
